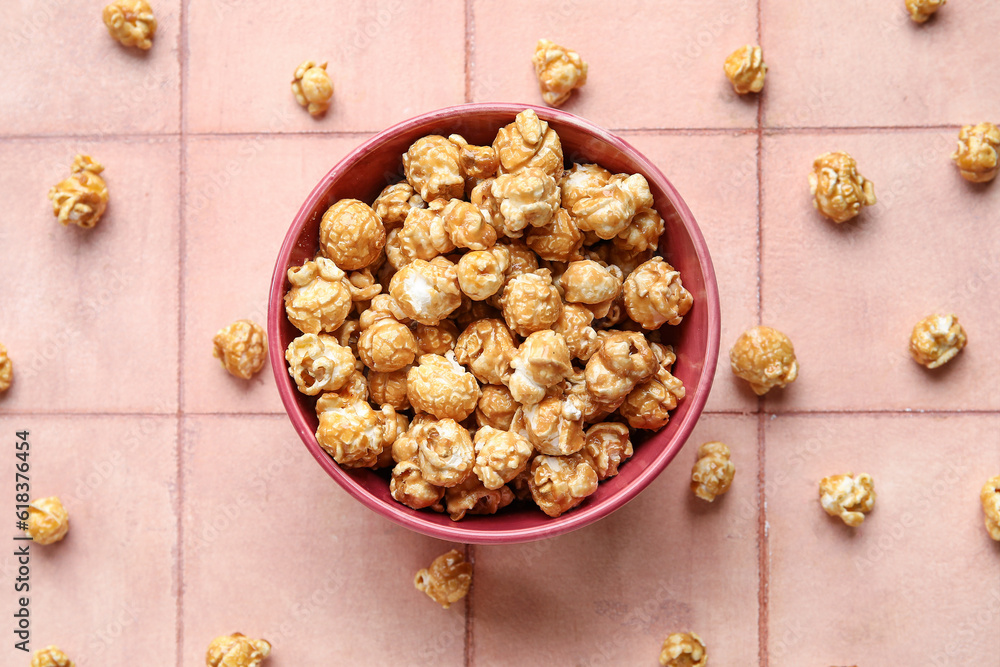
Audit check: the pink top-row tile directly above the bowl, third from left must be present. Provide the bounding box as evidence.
[472,0,757,130]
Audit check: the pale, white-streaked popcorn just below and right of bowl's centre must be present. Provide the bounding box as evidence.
[506,330,573,405]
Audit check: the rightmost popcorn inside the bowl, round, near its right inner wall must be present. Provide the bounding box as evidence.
[624,257,694,329]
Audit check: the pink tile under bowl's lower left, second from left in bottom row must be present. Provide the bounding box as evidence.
[182,416,465,667]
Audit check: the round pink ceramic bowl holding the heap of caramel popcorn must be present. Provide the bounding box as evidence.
[267,104,719,544]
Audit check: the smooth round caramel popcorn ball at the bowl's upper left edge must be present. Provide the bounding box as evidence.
[319,199,385,271]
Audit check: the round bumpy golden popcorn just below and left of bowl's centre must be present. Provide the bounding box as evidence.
[406,352,479,421]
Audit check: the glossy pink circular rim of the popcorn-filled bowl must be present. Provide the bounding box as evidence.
[267,102,721,544]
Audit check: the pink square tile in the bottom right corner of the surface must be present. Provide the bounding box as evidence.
[765,415,1000,667]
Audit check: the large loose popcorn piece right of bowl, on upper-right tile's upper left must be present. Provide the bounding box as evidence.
[809,152,876,223]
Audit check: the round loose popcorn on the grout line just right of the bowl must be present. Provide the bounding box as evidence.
[729,326,799,396]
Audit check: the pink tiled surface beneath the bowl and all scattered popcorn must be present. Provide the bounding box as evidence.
[0,0,1000,667]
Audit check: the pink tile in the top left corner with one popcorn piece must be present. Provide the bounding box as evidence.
[0,0,181,138]
